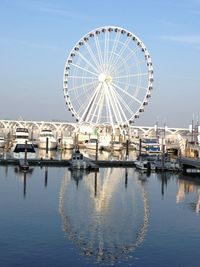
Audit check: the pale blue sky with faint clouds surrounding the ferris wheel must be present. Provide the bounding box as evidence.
[0,0,200,127]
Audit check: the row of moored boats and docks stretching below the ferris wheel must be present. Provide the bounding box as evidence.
[0,118,200,172]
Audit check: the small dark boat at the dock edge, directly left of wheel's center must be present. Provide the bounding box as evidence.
[69,147,98,170]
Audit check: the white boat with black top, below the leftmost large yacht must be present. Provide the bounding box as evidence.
[13,142,36,159]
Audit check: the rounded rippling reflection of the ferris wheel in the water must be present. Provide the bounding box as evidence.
[59,168,149,264]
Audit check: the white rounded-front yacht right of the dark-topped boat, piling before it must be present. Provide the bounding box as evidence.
[38,129,58,150]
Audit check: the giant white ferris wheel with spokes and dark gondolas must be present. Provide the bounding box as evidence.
[63,26,153,127]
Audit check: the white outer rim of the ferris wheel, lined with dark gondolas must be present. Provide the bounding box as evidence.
[63,26,154,128]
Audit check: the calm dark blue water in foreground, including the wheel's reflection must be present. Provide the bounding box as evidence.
[0,166,200,267]
